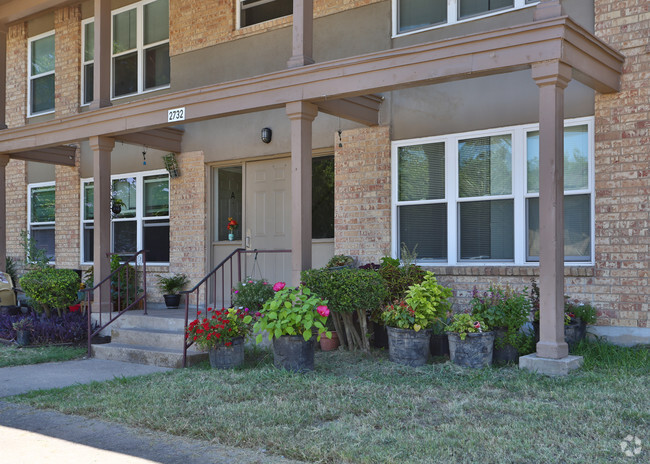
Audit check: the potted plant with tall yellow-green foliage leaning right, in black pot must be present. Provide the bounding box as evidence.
[382,272,453,366]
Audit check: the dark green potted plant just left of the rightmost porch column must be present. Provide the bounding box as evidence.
[470,285,531,362]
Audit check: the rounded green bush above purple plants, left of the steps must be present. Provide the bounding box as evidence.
[20,267,79,317]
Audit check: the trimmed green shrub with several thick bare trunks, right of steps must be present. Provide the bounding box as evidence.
[302,268,386,351]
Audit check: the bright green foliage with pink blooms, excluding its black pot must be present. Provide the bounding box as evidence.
[253,282,332,343]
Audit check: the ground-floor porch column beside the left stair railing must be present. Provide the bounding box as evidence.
[89,136,115,312]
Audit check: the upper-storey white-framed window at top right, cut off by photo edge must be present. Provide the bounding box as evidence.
[393,0,538,35]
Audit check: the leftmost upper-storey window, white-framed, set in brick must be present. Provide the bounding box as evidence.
[28,32,54,116]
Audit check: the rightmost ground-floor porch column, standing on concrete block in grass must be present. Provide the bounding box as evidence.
[532,61,571,359]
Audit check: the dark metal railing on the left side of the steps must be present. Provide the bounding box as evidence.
[82,250,147,357]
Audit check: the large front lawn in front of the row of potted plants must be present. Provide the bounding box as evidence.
[10,343,650,464]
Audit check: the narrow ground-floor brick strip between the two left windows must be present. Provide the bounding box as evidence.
[54,149,81,269]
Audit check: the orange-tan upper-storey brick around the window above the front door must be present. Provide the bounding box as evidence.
[169,0,385,56]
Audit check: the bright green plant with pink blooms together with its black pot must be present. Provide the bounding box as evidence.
[253,282,332,372]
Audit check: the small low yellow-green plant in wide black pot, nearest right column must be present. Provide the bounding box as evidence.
[447,313,494,368]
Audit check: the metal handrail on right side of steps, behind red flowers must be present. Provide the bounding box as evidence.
[180,248,291,367]
